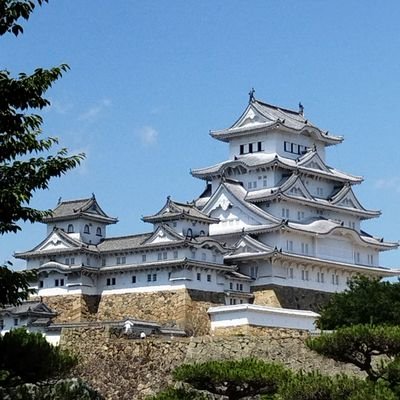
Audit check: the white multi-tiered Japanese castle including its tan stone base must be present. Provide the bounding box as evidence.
[16,91,398,334]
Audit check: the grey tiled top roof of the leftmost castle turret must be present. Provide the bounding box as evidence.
[43,196,117,224]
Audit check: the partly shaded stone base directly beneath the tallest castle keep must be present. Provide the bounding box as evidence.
[252,285,332,312]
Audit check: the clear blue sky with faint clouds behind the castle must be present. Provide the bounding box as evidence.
[0,0,400,267]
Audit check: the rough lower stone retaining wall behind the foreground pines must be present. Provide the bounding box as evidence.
[61,327,359,400]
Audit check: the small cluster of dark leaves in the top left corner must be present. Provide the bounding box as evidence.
[0,0,48,36]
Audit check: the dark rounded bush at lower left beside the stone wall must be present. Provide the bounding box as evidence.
[0,329,77,386]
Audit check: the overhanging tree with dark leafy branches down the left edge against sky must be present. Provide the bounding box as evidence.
[0,0,84,306]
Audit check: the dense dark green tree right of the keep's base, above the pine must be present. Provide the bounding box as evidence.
[317,276,400,330]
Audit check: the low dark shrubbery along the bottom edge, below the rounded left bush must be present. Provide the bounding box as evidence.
[0,379,103,400]
